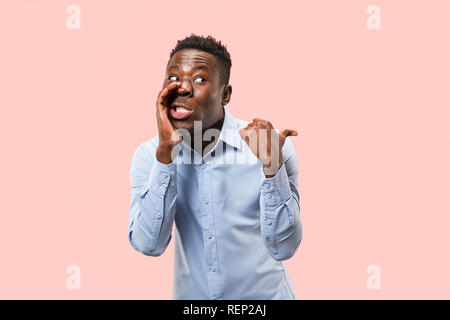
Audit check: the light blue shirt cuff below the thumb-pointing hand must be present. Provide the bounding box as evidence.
[261,163,291,207]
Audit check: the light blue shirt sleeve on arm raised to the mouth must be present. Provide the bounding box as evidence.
[128,144,177,256]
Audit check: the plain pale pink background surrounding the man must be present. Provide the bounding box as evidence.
[0,0,450,299]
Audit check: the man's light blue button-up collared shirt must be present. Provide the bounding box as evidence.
[129,108,302,300]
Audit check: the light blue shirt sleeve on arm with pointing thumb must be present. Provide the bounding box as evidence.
[260,138,303,261]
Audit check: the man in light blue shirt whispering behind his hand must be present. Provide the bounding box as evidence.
[129,34,302,299]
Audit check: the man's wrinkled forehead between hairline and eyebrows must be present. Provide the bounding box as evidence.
[167,49,217,72]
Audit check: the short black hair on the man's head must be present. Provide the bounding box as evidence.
[169,33,231,85]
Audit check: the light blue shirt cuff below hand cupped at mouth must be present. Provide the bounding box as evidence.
[140,160,177,198]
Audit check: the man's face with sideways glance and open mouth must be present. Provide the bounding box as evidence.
[164,49,227,133]
